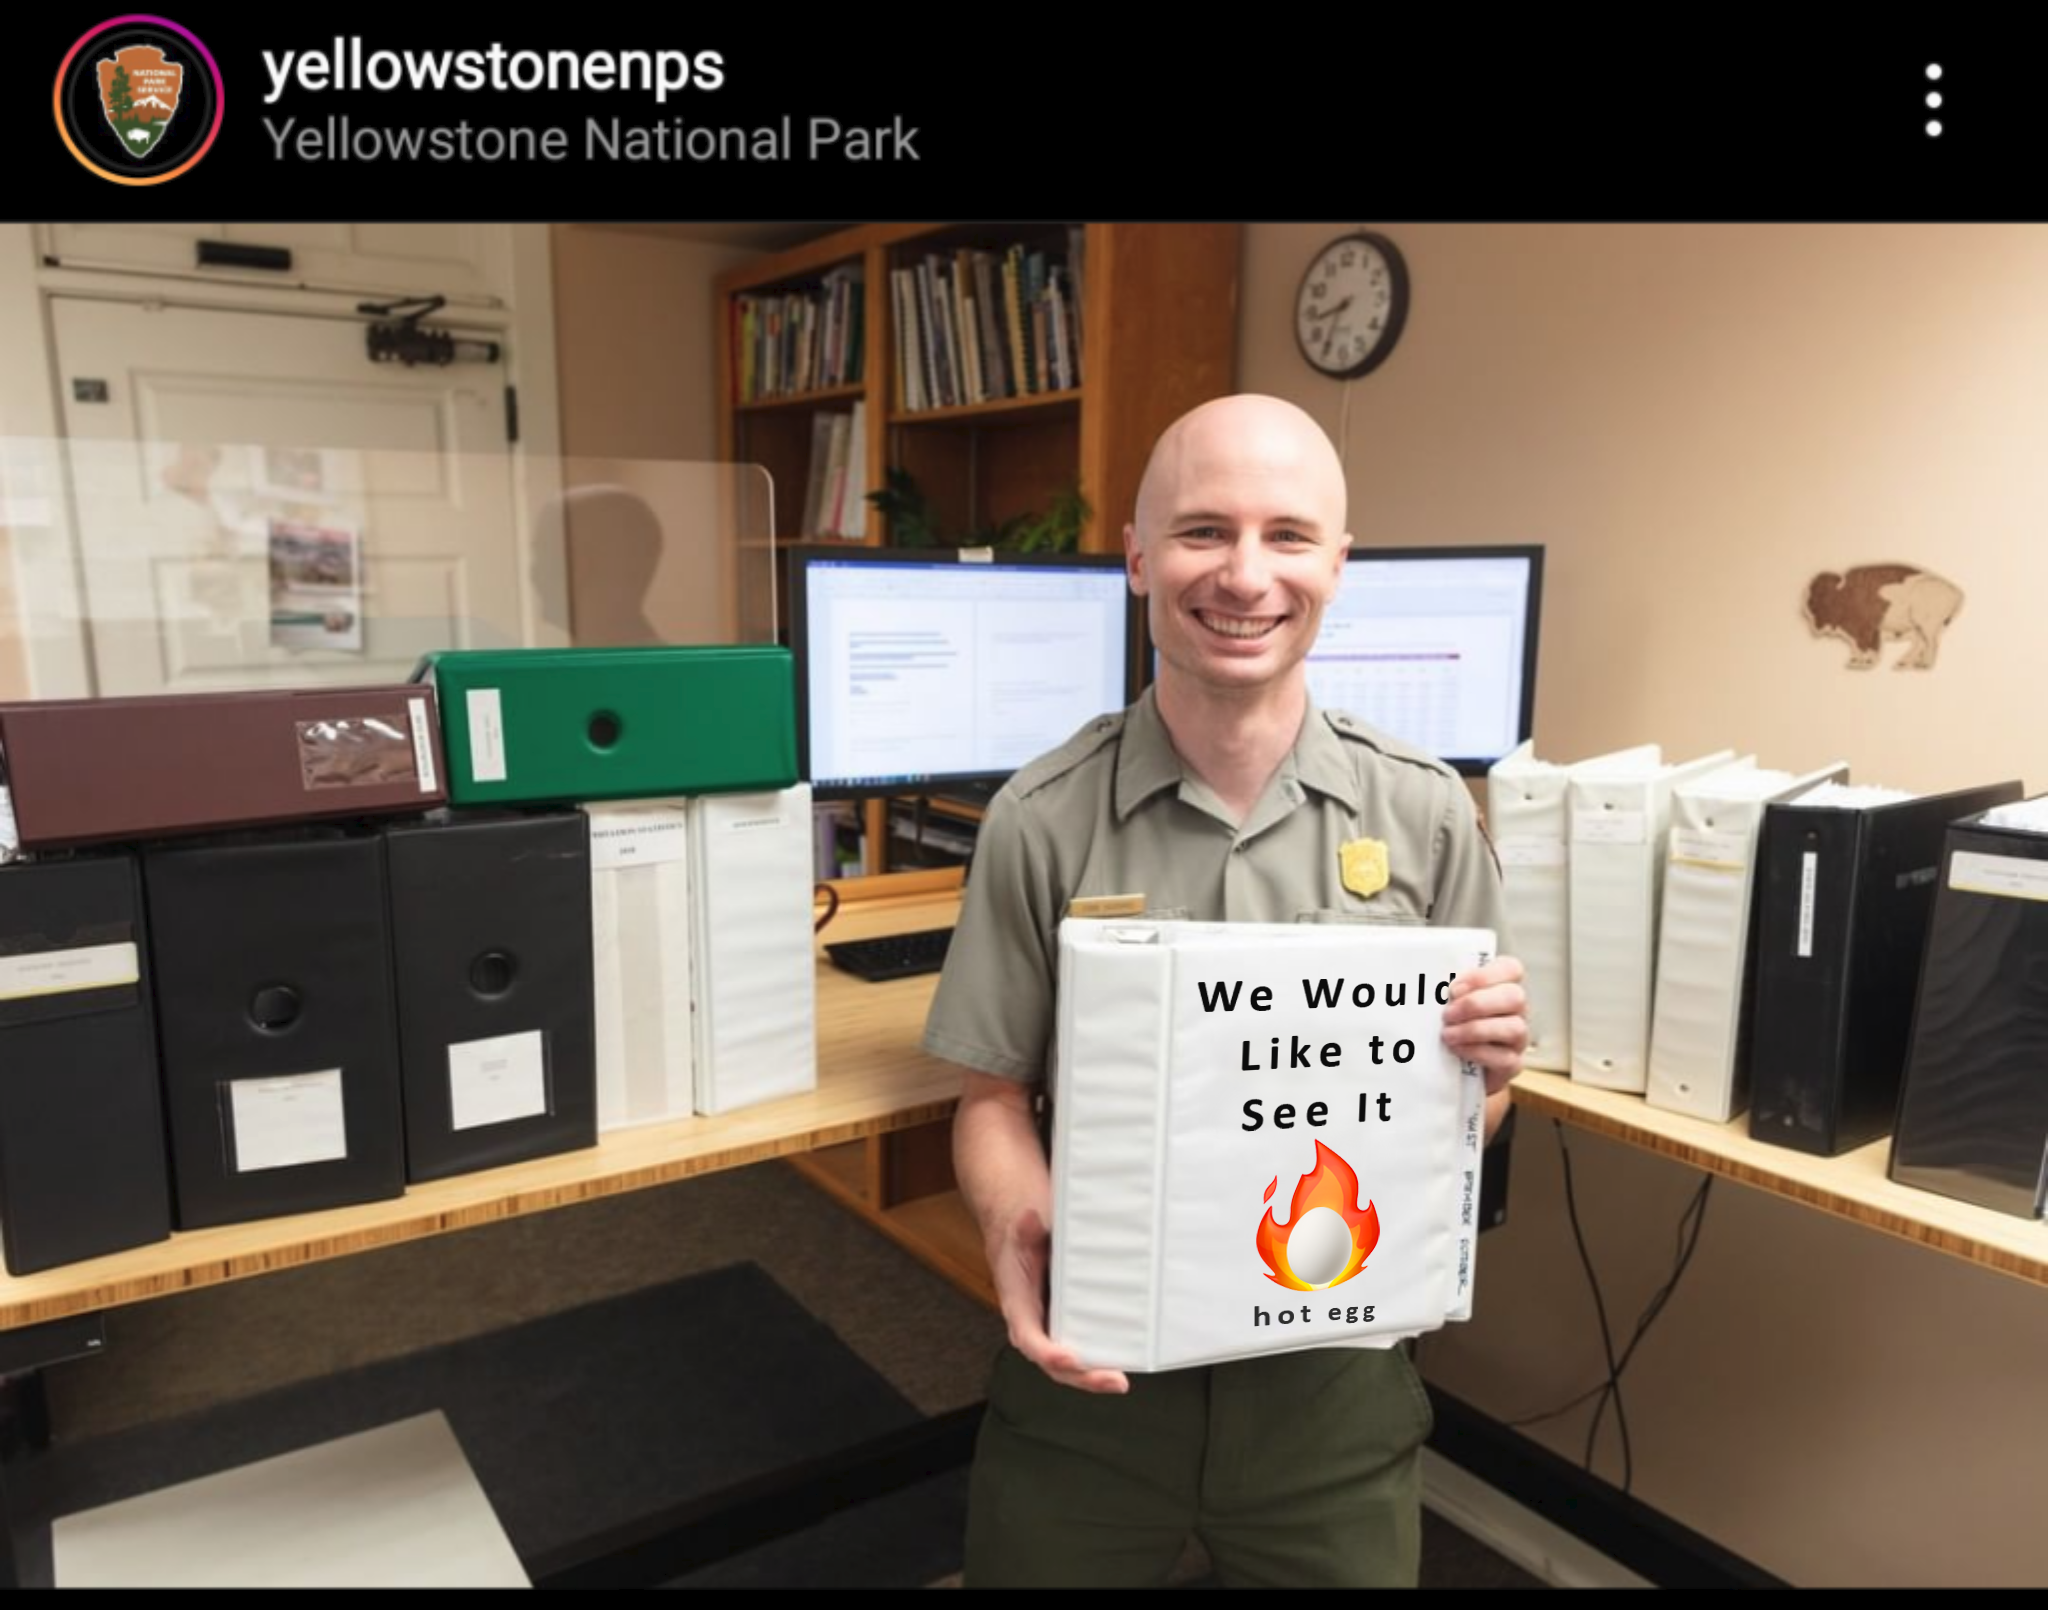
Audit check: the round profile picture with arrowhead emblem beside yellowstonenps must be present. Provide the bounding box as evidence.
[55,16,221,184]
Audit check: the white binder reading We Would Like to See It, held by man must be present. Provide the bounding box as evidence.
[1051,918,1495,1370]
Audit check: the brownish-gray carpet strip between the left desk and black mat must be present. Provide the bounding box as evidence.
[19,1163,1540,1587]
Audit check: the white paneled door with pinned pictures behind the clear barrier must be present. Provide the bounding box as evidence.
[51,297,540,694]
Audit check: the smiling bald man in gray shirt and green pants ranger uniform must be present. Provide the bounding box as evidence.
[924,395,1528,1585]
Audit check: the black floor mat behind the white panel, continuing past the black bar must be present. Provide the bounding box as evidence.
[18,1264,967,1587]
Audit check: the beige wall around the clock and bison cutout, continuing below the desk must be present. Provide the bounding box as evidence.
[1239,225,2048,1585]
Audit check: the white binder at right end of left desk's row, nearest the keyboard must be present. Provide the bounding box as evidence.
[690,782,817,1116]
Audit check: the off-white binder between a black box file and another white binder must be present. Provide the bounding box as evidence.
[584,799,696,1135]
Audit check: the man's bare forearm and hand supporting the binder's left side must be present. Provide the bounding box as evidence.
[952,1071,1130,1393]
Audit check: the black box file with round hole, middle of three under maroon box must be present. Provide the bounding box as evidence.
[143,830,406,1229]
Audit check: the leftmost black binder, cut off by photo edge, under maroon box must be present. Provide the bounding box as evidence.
[0,854,170,1274]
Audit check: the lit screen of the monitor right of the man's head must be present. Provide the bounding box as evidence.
[1147,543,1544,776]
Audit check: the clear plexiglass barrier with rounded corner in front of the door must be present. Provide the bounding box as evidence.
[0,432,778,698]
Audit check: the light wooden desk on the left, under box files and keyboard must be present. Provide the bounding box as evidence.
[0,879,979,1329]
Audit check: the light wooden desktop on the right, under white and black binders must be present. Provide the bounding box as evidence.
[1509,1071,2048,1286]
